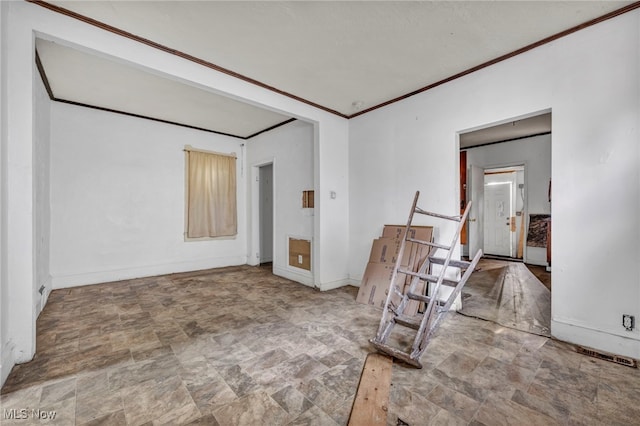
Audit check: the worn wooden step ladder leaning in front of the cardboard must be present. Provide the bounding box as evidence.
[370,191,482,368]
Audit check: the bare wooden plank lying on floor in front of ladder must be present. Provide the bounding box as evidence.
[349,353,393,426]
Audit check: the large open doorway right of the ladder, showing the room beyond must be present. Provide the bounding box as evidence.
[458,111,551,336]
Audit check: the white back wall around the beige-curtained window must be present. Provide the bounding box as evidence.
[51,102,246,288]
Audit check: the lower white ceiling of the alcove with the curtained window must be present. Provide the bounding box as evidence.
[36,39,290,137]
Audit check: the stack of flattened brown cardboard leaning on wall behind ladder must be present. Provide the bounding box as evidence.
[356,225,433,315]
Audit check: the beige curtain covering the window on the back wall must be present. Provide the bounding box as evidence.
[187,151,238,238]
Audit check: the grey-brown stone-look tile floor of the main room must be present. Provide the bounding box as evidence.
[0,266,640,425]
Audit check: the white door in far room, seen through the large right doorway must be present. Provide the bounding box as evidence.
[484,181,513,257]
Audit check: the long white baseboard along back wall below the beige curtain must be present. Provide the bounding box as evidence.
[51,256,247,290]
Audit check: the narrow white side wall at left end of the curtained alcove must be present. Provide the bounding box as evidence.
[33,69,51,317]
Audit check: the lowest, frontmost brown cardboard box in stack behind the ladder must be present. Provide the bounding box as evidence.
[356,262,406,308]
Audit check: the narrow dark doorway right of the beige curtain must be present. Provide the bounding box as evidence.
[258,163,274,269]
